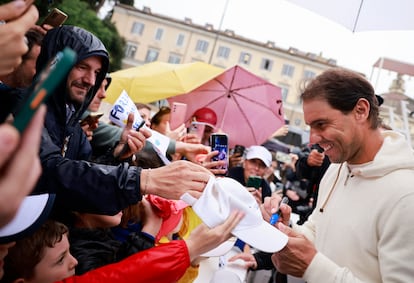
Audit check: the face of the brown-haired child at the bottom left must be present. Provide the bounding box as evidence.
[29,234,78,283]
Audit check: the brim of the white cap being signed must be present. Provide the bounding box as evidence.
[232,221,288,253]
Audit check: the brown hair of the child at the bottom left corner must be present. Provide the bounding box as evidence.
[0,220,68,283]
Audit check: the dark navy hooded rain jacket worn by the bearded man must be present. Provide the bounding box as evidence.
[35,26,141,219]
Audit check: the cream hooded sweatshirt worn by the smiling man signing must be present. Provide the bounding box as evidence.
[295,131,414,283]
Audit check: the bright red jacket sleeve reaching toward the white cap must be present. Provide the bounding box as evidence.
[55,240,190,283]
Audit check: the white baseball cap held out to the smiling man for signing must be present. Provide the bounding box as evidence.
[181,177,288,253]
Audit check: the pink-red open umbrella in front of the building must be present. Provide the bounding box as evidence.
[168,66,284,147]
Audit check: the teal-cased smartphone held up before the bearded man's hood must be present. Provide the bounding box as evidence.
[13,47,77,132]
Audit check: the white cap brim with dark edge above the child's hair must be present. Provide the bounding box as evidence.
[0,194,55,244]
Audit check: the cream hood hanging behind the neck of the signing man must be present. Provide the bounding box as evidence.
[351,131,414,178]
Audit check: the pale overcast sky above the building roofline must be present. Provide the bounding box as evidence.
[130,0,414,97]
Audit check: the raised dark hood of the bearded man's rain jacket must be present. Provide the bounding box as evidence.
[36,25,109,125]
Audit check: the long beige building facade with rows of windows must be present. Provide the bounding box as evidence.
[112,5,336,134]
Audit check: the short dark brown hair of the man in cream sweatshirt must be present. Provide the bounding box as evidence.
[301,68,380,129]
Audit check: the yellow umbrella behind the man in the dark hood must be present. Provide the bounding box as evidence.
[106,61,224,104]
